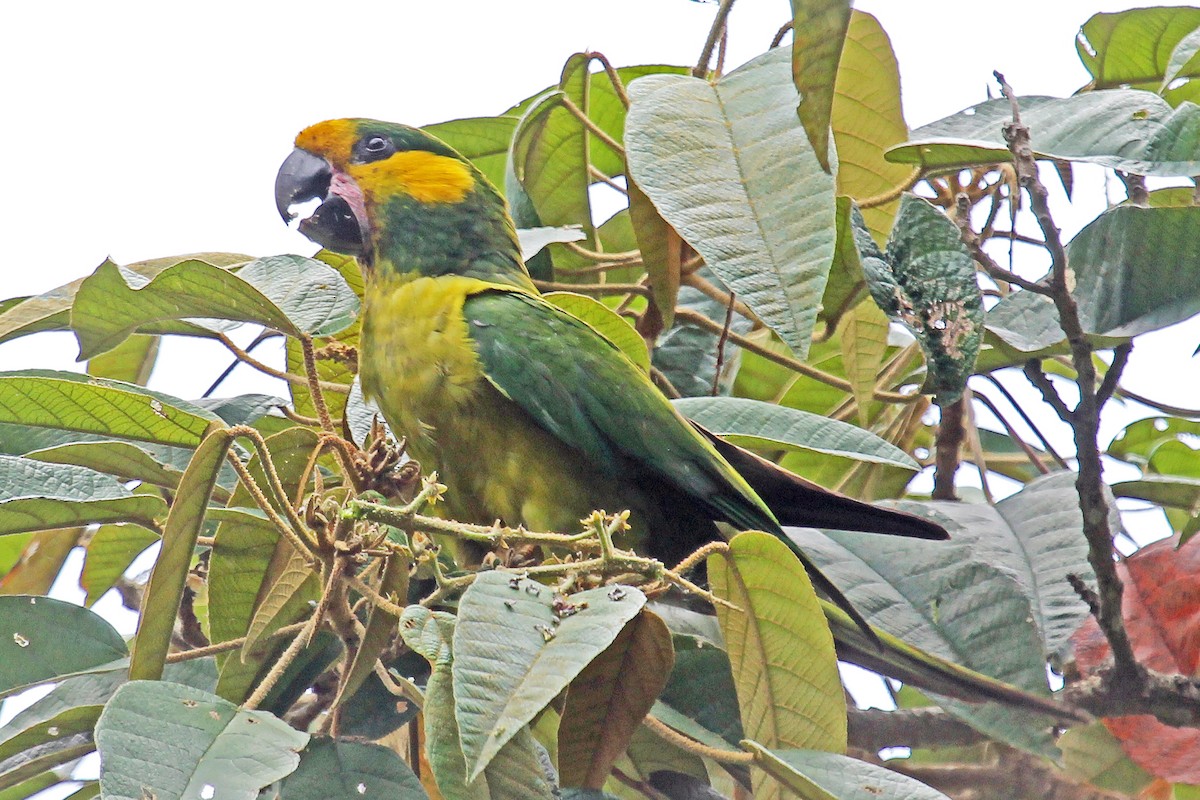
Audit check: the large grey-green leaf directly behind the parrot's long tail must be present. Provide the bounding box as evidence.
[787,525,1054,753]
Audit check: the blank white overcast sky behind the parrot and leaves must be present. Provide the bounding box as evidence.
[0,0,1200,786]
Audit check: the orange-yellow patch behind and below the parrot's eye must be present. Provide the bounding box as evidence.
[347,150,475,203]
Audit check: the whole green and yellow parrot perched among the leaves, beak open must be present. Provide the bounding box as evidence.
[275,119,1094,718]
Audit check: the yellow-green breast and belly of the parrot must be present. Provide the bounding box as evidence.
[360,273,653,533]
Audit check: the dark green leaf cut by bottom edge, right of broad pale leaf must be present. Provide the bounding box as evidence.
[280,736,430,800]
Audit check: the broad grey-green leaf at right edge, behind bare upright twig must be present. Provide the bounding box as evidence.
[986,206,1200,353]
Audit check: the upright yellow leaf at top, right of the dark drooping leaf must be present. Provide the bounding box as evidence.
[827,10,912,244]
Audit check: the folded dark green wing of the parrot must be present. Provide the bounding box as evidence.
[463,290,779,533]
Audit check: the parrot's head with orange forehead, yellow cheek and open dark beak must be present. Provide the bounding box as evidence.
[275,119,532,288]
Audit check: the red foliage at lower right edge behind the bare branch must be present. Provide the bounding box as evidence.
[1072,540,1200,783]
